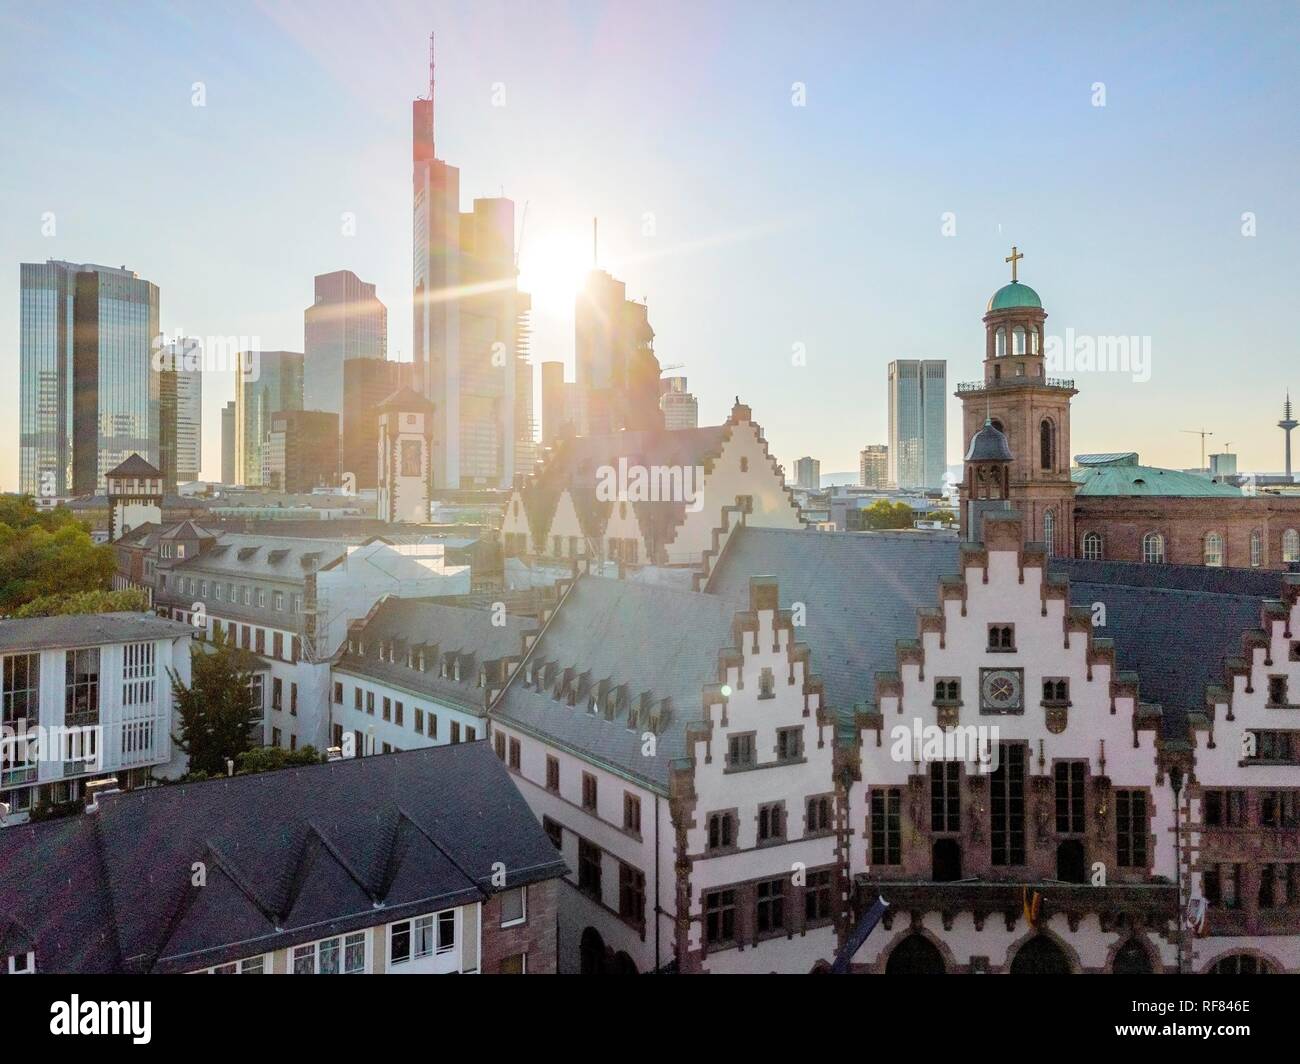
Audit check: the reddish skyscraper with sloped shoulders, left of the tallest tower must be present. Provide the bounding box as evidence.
[303,269,389,416]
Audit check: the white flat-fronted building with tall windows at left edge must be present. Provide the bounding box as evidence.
[0,613,194,826]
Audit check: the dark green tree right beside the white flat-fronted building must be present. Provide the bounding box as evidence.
[168,629,261,775]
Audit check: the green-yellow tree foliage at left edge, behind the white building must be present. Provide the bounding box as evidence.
[0,496,114,614]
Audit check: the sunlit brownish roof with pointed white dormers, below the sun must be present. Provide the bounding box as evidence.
[523,425,735,552]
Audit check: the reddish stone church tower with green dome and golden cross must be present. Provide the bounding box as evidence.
[957,247,1075,558]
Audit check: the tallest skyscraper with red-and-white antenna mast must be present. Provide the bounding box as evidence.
[412,38,534,488]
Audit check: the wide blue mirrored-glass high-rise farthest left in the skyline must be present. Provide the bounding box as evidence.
[18,259,160,496]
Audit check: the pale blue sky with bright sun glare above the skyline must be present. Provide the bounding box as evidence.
[0,0,1300,490]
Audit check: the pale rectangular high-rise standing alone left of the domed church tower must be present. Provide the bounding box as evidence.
[889,359,948,488]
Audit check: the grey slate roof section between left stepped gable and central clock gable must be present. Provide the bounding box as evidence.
[705,525,959,719]
